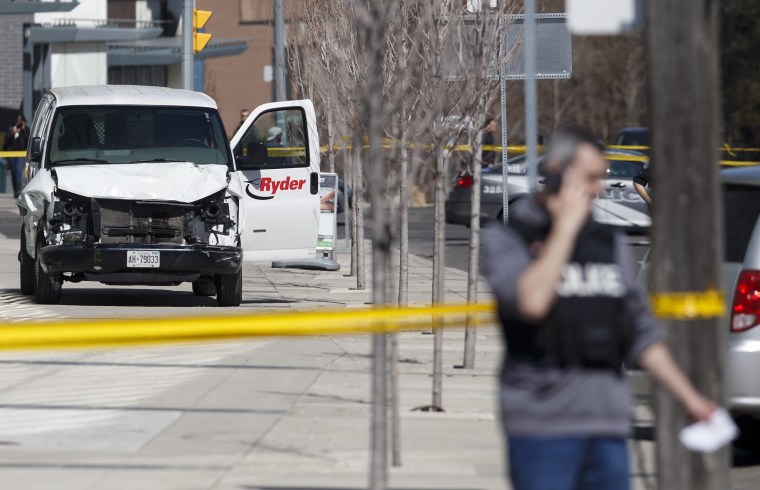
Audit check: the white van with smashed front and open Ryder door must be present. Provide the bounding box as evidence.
[17,85,319,306]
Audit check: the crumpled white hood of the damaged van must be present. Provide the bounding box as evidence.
[54,162,227,203]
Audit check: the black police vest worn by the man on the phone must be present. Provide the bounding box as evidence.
[499,214,631,373]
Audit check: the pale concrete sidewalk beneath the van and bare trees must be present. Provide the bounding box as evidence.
[0,193,506,490]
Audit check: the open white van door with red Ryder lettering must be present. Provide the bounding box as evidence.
[230,100,319,261]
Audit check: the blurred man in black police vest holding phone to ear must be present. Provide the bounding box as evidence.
[483,126,716,490]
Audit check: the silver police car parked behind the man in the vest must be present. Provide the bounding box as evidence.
[446,150,651,233]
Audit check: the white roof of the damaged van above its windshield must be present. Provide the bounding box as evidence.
[49,85,216,109]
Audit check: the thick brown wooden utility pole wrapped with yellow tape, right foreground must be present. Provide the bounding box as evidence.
[647,0,729,490]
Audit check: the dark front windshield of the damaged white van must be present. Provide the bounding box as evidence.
[49,106,230,166]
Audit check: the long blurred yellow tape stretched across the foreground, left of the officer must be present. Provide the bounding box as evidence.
[0,303,496,350]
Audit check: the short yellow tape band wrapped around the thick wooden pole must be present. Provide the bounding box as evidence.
[649,290,726,320]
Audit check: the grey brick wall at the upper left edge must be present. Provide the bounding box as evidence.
[0,14,33,113]
